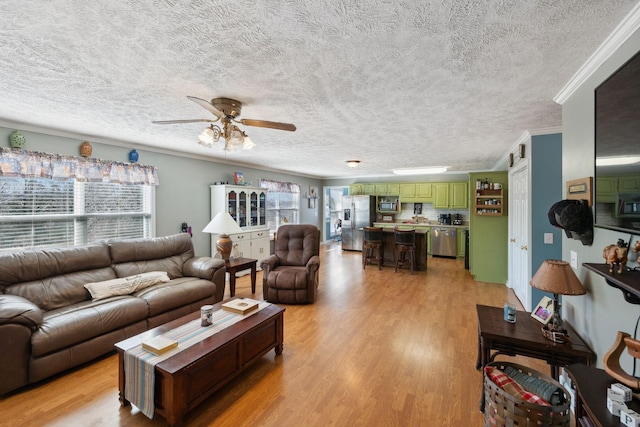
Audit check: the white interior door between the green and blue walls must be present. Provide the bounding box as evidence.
[508,164,531,311]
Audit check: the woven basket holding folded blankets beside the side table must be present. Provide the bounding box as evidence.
[483,362,571,427]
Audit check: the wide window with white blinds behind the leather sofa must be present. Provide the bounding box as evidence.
[0,177,154,250]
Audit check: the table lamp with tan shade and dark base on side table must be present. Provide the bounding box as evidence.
[529,259,587,343]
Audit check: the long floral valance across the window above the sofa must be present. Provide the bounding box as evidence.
[0,147,159,185]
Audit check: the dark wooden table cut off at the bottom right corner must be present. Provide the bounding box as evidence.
[565,364,640,427]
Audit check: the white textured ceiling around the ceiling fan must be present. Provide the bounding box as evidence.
[0,0,637,177]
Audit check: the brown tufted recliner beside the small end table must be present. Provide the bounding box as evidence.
[261,224,320,304]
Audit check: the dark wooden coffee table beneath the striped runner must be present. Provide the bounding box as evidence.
[115,303,285,426]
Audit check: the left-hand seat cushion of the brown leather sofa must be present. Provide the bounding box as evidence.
[31,296,149,357]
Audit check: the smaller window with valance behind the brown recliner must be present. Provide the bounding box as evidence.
[260,179,300,232]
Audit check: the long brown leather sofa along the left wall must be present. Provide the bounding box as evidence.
[0,233,225,395]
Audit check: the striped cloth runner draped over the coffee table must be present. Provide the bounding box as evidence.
[124,301,271,418]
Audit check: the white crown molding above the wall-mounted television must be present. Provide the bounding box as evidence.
[553,2,640,105]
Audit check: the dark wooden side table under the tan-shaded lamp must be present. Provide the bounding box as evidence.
[476,305,595,412]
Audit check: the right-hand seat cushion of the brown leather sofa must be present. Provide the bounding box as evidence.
[132,277,216,317]
